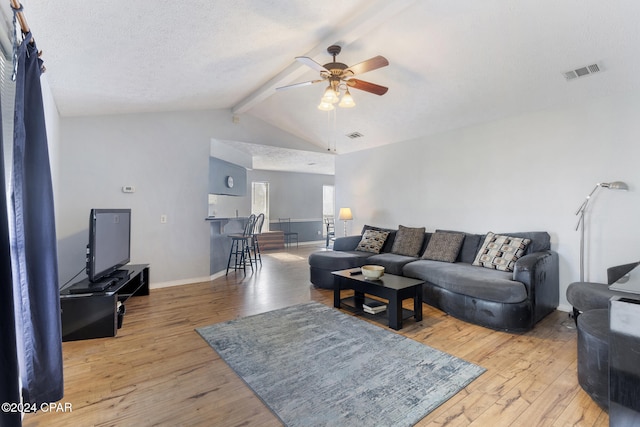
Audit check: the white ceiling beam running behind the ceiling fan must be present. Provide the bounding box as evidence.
[231,0,417,114]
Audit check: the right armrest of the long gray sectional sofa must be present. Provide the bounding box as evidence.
[513,250,560,322]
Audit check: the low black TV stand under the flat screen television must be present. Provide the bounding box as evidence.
[60,264,149,341]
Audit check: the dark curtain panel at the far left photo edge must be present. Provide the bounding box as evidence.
[0,63,22,427]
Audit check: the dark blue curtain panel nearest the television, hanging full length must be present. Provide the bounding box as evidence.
[11,33,64,404]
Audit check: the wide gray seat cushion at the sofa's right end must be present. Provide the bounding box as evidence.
[402,259,527,303]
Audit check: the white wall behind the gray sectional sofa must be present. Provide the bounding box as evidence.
[336,96,640,309]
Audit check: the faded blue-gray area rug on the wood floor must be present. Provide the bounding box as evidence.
[197,302,485,427]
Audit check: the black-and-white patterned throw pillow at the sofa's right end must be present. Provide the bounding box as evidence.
[472,232,531,271]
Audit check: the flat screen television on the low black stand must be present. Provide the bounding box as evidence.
[87,209,131,282]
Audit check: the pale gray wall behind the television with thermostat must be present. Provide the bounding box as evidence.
[57,110,316,286]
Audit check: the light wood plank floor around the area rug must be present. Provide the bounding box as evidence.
[24,246,609,427]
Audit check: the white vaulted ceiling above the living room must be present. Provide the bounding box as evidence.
[11,0,640,172]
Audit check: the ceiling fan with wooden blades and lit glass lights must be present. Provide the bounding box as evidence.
[276,45,389,111]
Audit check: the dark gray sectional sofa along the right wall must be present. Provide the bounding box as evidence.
[309,226,559,332]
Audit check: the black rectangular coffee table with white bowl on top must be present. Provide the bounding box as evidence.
[331,268,424,331]
